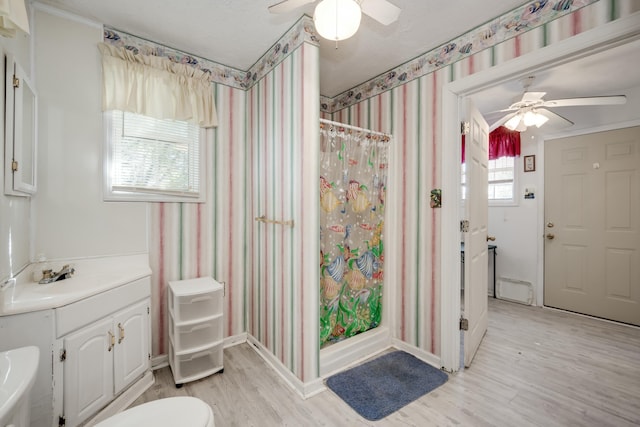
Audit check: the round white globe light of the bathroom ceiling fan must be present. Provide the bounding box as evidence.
[313,0,362,41]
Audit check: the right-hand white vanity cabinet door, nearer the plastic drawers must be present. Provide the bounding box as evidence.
[113,300,150,394]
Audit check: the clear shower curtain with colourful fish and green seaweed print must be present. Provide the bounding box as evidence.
[320,120,391,347]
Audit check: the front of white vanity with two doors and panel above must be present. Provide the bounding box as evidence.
[54,277,151,427]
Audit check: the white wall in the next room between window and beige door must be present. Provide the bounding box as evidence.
[489,132,543,305]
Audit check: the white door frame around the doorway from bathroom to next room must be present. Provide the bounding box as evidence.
[440,13,640,372]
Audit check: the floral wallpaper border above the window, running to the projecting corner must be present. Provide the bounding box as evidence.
[104,15,319,90]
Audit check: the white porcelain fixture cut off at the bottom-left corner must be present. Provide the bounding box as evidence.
[0,346,40,426]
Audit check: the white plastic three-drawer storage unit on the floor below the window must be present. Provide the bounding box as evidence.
[168,277,224,387]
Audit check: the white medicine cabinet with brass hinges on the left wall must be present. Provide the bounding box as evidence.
[2,49,38,197]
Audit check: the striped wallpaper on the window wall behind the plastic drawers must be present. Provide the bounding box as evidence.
[149,84,249,355]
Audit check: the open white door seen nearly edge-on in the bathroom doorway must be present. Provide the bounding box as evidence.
[463,100,489,366]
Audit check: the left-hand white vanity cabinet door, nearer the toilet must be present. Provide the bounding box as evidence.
[63,317,114,426]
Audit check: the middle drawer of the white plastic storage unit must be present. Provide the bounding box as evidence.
[169,314,222,354]
